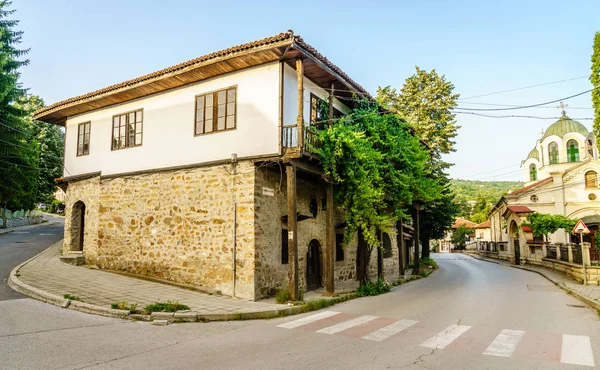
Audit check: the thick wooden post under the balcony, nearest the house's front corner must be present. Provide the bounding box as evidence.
[285,165,300,301]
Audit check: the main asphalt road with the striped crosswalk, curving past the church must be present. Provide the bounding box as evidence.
[0,233,600,370]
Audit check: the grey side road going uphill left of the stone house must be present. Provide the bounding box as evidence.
[0,216,64,301]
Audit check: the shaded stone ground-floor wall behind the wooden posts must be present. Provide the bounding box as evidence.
[255,166,398,297]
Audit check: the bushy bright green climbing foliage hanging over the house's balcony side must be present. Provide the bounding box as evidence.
[318,102,439,284]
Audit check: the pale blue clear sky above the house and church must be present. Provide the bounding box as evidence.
[12,0,600,181]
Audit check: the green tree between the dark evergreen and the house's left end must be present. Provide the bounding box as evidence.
[15,95,64,203]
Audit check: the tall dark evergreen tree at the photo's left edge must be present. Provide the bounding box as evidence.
[0,1,39,209]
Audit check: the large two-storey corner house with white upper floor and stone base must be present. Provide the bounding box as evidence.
[35,32,410,299]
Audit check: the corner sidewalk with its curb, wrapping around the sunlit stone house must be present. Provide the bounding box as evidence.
[10,241,292,320]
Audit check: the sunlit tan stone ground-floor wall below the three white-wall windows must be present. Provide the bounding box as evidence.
[65,162,255,299]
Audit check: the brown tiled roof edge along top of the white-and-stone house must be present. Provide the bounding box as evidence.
[34,30,371,117]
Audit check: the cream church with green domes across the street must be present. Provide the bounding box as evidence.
[487,112,600,278]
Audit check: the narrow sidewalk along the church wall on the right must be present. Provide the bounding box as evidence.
[469,254,600,310]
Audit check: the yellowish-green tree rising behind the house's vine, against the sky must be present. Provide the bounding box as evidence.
[377,67,460,169]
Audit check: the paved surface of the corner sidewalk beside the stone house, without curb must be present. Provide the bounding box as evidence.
[18,242,286,314]
